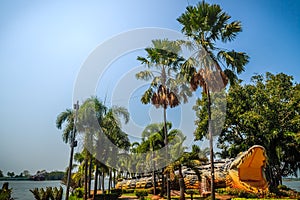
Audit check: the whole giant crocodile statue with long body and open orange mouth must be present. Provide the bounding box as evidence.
[117,145,268,194]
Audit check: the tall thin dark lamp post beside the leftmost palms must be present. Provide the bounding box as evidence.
[66,101,79,200]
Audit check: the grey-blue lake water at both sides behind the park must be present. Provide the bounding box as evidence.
[0,181,300,200]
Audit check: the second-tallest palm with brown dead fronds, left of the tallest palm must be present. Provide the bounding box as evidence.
[136,39,190,199]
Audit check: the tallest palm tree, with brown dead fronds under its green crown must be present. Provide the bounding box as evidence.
[177,1,249,199]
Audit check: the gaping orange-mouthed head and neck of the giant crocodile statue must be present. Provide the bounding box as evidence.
[199,145,268,193]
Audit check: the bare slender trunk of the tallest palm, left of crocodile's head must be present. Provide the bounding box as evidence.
[206,89,215,200]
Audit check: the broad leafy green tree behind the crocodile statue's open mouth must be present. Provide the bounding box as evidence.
[218,73,300,189]
